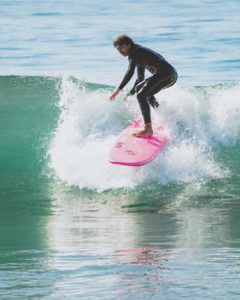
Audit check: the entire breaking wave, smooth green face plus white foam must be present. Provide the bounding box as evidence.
[0,76,240,191]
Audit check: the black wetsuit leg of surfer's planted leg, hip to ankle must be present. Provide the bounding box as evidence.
[136,73,177,124]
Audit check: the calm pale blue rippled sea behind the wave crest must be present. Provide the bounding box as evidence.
[0,0,240,86]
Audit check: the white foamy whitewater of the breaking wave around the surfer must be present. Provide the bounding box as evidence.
[48,78,240,190]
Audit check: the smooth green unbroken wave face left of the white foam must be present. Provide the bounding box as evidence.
[0,76,61,192]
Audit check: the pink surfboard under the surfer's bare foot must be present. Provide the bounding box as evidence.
[109,120,168,166]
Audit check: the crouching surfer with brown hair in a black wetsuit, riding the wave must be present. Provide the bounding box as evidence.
[109,34,177,137]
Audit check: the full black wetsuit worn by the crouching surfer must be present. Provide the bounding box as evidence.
[119,44,177,124]
